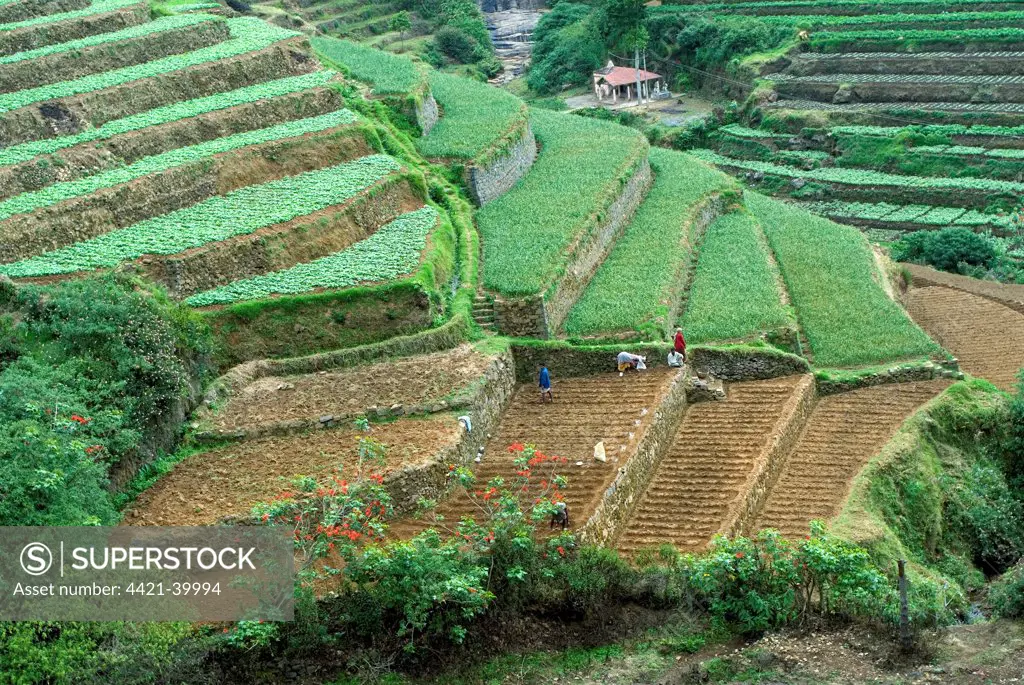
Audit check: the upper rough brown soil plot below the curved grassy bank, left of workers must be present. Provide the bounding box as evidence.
[211,345,490,430]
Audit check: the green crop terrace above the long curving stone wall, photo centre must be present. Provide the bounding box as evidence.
[477,111,648,295]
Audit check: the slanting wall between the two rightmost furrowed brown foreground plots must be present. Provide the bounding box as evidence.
[719,376,817,537]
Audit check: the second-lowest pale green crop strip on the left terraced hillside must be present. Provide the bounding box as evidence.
[0,155,400,277]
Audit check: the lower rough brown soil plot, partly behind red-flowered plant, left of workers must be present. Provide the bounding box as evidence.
[125,415,460,525]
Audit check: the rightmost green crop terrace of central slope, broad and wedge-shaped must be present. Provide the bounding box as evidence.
[745,192,938,367]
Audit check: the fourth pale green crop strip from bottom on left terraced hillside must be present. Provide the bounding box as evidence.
[0,70,337,166]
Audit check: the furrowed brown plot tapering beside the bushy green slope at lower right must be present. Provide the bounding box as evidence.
[756,380,950,539]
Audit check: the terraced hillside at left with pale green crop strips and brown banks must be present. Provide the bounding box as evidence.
[0,0,458,365]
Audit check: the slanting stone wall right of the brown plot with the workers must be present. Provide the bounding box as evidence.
[577,371,689,547]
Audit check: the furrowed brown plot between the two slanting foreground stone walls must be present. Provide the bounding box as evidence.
[618,376,807,554]
